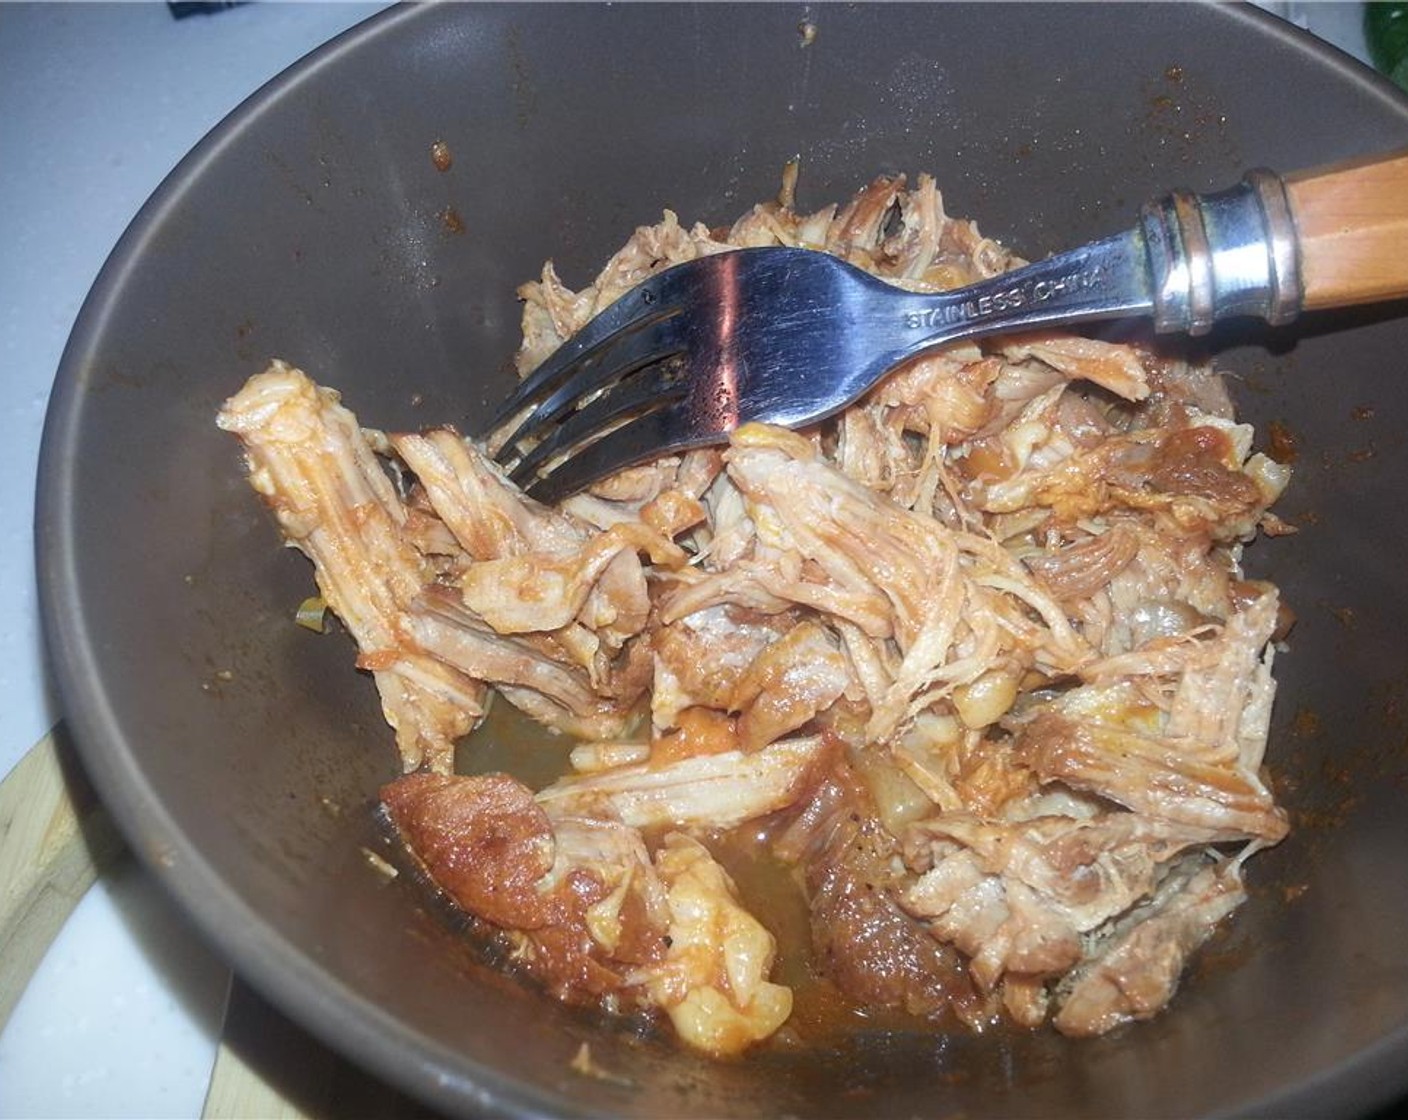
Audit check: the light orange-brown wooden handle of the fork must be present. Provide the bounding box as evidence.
[1286,151,1408,310]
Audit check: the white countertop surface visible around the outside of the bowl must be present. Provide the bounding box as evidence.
[0,1,1364,1120]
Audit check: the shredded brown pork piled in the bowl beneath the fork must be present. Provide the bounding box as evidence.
[218,176,1287,1054]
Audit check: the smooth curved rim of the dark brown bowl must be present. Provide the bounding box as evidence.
[35,0,1408,1116]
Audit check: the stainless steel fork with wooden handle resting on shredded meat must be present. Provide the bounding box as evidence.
[489,155,1408,500]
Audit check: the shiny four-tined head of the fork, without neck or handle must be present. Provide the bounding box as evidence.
[490,248,900,500]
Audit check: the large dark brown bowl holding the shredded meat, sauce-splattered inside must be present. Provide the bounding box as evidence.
[30,4,1408,1117]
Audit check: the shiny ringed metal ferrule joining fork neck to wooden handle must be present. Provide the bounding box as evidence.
[1138,170,1301,335]
